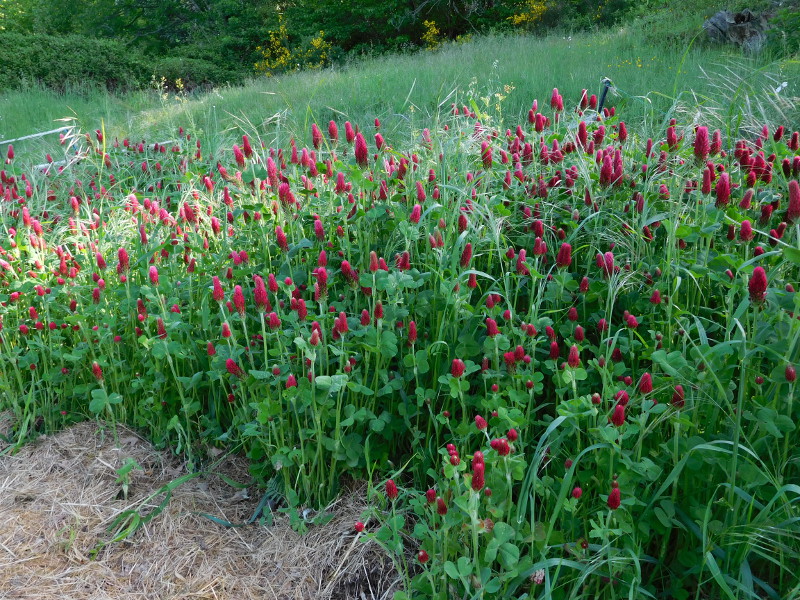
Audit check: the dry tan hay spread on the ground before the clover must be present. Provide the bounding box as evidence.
[0,423,399,600]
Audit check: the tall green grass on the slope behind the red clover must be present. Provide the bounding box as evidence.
[0,28,798,151]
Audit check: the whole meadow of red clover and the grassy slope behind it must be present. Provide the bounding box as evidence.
[0,27,800,599]
